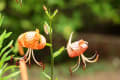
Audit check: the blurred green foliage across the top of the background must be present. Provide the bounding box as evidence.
[0,0,120,39]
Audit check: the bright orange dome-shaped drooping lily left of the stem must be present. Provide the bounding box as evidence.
[18,29,46,66]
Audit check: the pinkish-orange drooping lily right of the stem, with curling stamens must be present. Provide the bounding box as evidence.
[67,32,99,72]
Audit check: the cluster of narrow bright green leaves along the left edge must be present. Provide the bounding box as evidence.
[0,30,20,80]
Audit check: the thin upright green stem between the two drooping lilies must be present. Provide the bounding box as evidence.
[49,19,54,80]
